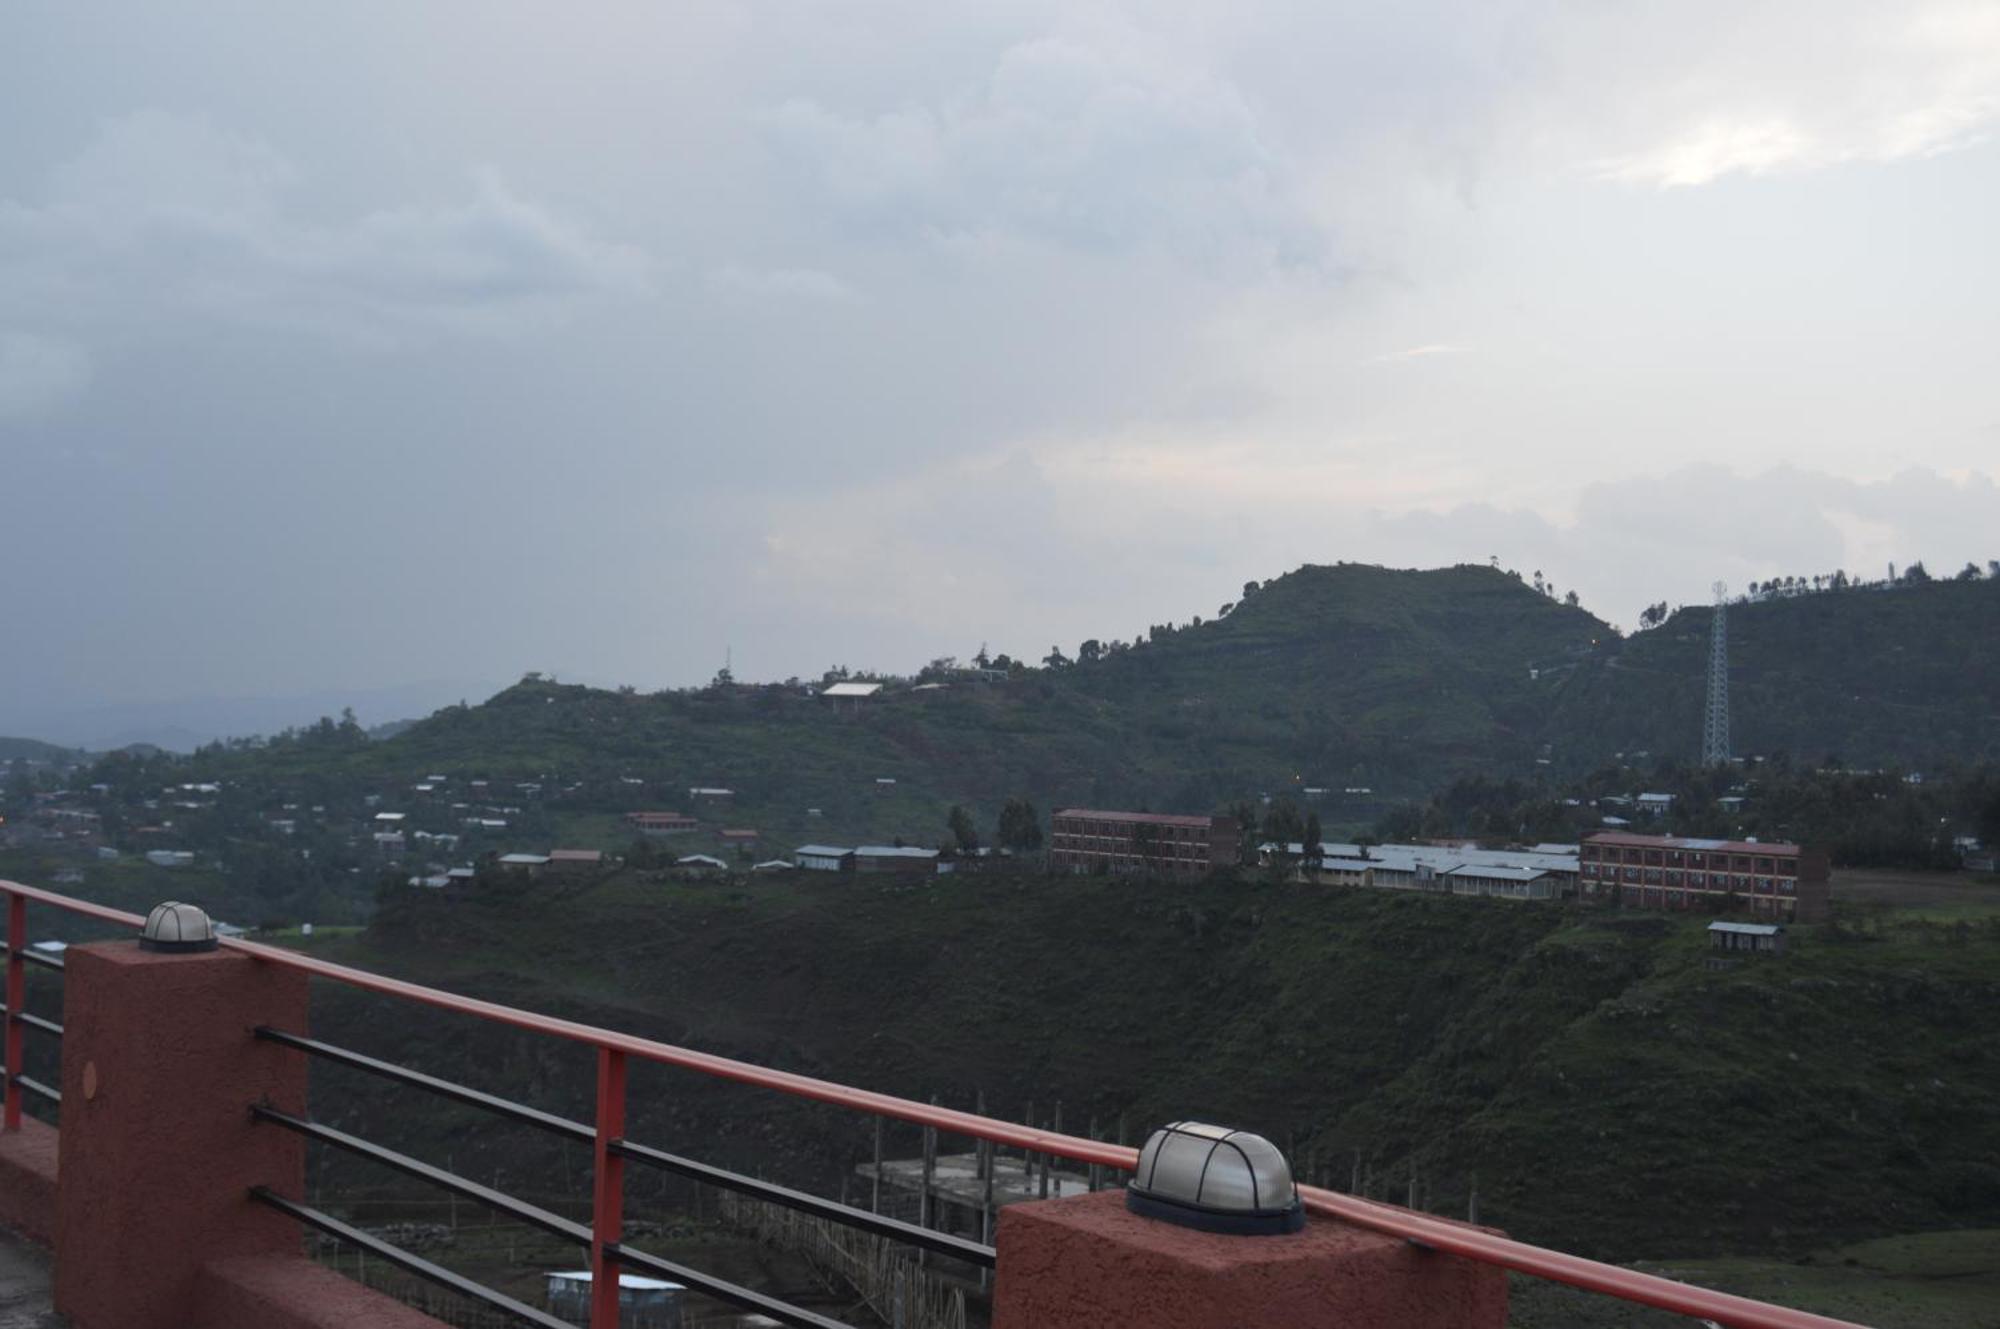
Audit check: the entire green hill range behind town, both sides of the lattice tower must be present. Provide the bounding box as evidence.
[172,564,2000,839]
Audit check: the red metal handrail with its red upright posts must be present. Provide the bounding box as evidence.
[0,881,1866,1329]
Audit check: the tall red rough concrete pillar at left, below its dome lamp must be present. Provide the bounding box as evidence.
[56,941,306,1329]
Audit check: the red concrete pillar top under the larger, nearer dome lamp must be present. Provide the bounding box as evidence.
[992,1191,1506,1329]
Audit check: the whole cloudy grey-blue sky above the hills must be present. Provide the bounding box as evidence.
[0,0,2000,733]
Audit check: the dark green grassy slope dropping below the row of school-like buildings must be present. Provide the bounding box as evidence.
[290,875,2000,1257]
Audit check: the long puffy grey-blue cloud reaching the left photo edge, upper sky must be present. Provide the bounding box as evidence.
[0,110,654,344]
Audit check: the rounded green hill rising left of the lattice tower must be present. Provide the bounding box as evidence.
[180,564,1610,837]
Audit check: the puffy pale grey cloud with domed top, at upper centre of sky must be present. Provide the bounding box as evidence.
[762,26,1322,262]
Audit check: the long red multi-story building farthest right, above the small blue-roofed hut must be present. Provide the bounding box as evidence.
[1576,831,1828,923]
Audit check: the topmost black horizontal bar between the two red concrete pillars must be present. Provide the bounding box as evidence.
[256,1025,994,1269]
